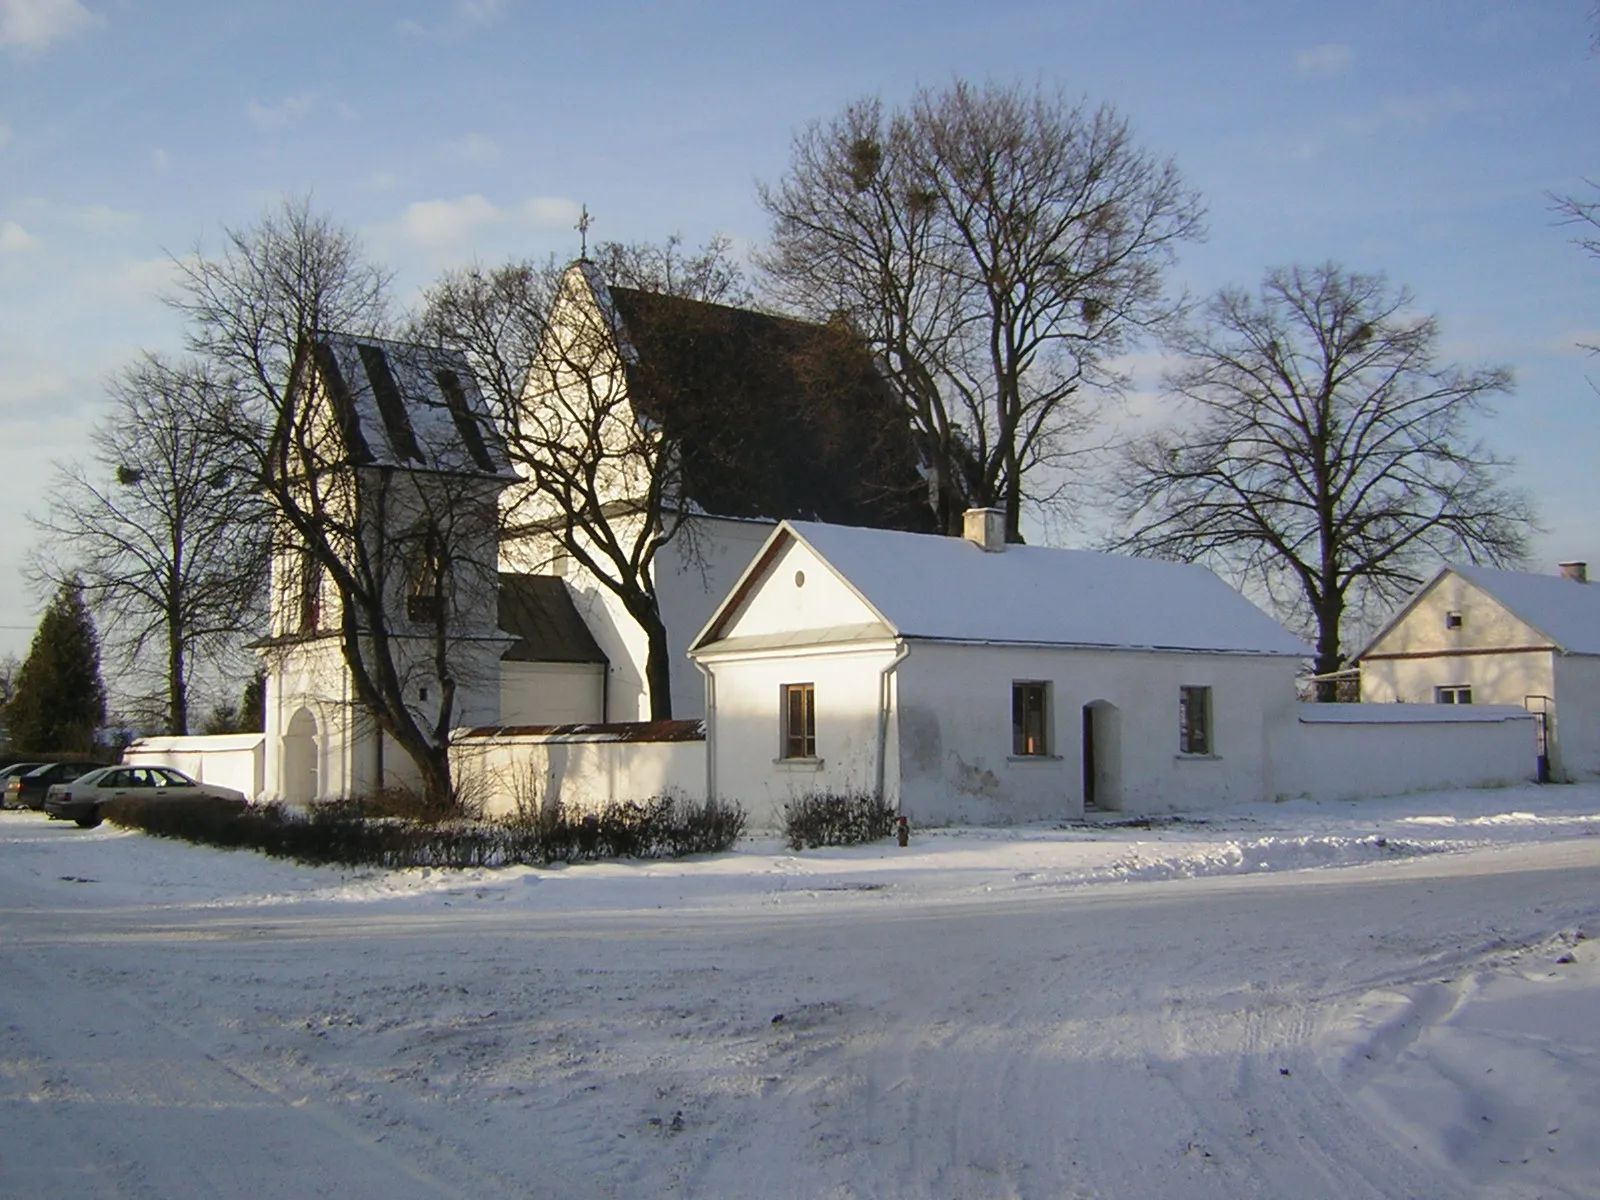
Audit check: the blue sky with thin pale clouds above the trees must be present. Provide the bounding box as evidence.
[0,0,1600,668]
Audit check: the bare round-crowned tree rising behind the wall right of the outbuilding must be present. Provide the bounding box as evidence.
[1118,264,1533,699]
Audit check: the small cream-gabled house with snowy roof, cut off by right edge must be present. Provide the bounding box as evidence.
[1355,566,1600,781]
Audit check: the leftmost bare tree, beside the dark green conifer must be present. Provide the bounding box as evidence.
[34,357,269,734]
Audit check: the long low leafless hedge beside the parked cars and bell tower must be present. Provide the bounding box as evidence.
[102,797,744,869]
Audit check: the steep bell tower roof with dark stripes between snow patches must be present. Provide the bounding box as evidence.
[302,333,510,475]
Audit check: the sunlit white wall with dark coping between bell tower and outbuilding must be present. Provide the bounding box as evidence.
[450,722,706,816]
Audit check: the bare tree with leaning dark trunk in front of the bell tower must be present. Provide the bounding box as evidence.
[170,200,494,806]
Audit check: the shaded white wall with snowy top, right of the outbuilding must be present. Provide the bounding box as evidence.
[1274,704,1538,800]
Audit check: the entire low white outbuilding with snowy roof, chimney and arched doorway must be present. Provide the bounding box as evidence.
[690,510,1307,824]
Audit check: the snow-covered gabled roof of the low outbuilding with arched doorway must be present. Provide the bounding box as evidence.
[691,522,1310,658]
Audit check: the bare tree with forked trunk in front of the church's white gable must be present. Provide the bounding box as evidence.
[418,237,749,720]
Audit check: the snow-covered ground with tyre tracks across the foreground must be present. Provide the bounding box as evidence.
[0,786,1600,1200]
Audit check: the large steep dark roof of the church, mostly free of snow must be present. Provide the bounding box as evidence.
[610,288,934,531]
